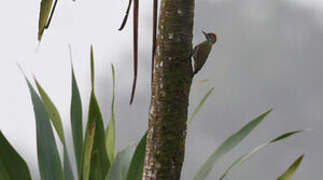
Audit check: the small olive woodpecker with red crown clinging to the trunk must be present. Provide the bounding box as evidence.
[193,31,217,76]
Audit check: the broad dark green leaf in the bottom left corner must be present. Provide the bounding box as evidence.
[0,130,31,180]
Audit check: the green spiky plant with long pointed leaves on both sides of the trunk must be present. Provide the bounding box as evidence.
[0,47,304,180]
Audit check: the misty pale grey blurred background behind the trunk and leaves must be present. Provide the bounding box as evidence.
[0,0,323,180]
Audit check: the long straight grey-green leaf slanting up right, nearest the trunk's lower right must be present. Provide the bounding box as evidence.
[194,110,272,180]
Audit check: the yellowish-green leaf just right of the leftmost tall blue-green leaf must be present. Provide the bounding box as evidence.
[34,78,74,180]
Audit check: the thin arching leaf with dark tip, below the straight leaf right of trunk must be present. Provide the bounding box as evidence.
[220,130,305,180]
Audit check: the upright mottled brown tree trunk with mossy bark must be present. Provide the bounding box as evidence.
[142,0,194,180]
